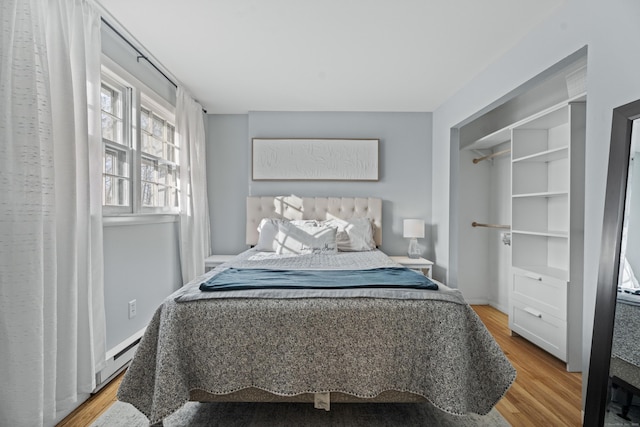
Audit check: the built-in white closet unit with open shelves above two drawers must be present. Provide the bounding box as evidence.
[509,102,585,371]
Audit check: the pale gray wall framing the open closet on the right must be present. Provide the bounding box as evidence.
[433,0,640,404]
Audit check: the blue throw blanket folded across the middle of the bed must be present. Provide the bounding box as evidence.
[200,267,438,291]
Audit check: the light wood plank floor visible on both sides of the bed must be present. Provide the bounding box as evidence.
[57,305,582,427]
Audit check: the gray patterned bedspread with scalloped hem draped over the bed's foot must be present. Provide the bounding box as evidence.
[118,251,515,423]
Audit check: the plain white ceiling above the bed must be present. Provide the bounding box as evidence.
[99,0,566,113]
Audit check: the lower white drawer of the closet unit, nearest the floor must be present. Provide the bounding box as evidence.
[509,301,567,362]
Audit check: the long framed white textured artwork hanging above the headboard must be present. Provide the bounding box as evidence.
[251,138,380,181]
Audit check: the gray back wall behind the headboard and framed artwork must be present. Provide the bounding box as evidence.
[207,112,433,258]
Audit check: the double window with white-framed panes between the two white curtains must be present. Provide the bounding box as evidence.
[100,67,180,215]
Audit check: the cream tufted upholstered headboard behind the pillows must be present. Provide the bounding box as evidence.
[246,196,382,247]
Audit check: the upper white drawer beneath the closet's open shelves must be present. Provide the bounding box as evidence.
[510,271,567,320]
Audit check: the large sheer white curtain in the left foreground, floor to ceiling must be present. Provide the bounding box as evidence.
[0,0,105,426]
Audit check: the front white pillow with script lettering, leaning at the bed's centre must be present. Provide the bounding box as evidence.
[275,222,338,255]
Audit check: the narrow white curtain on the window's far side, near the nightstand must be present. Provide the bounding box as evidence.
[176,86,211,283]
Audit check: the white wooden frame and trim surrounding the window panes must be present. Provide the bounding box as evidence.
[102,55,182,217]
